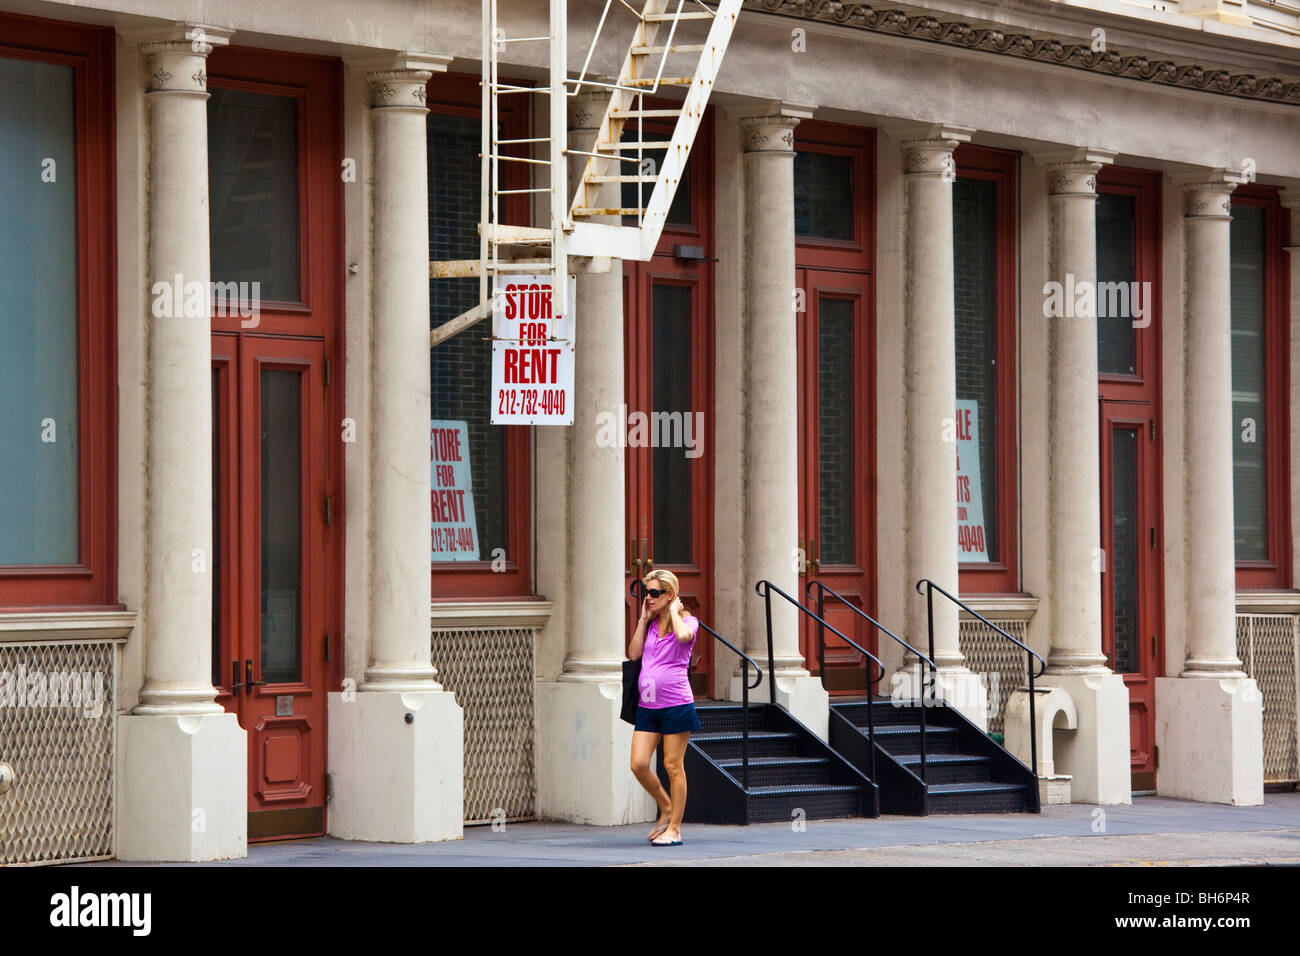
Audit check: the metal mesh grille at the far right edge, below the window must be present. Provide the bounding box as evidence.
[1236,614,1300,783]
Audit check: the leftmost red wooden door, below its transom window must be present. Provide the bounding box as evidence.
[213,336,333,839]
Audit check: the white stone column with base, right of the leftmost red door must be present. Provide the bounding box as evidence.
[329,53,464,843]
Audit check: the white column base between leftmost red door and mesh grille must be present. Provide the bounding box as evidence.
[328,691,465,843]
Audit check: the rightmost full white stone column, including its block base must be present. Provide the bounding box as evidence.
[1156,169,1264,805]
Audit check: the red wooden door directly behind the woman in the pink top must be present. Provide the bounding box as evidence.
[624,256,729,697]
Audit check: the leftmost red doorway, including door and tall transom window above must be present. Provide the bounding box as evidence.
[208,48,347,840]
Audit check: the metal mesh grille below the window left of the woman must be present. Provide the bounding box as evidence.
[433,627,537,823]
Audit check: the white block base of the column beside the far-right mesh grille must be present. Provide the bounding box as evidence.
[1156,678,1264,806]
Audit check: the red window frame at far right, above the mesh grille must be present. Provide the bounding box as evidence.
[1232,185,1292,591]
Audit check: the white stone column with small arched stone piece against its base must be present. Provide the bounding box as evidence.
[1026,148,1132,804]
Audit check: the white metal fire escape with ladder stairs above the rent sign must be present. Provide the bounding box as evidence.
[430,0,742,345]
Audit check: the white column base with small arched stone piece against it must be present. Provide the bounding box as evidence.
[1026,671,1134,806]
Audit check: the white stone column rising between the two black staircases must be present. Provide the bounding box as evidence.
[731,107,828,737]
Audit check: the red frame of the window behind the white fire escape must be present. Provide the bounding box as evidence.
[425,73,533,601]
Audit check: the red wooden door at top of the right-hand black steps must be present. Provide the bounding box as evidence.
[797,269,878,695]
